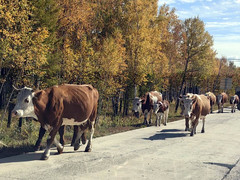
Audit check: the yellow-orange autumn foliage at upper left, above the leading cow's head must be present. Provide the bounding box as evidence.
[0,0,48,85]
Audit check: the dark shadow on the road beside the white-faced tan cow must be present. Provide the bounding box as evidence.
[143,129,189,141]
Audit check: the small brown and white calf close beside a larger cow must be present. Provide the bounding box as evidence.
[153,100,169,126]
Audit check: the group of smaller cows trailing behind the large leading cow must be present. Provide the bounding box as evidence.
[132,91,239,136]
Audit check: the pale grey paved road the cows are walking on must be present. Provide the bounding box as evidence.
[0,109,240,180]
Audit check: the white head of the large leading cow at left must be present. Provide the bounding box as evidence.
[12,87,36,117]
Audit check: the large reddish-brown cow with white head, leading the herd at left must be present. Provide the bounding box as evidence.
[12,84,99,160]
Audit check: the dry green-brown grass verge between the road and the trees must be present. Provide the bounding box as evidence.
[0,104,229,158]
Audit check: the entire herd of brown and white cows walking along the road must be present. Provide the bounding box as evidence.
[12,84,239,160]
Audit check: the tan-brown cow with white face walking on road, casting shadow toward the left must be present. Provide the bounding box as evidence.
[182,94,210,136]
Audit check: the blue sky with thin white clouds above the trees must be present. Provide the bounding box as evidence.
[158,0,240,66]
